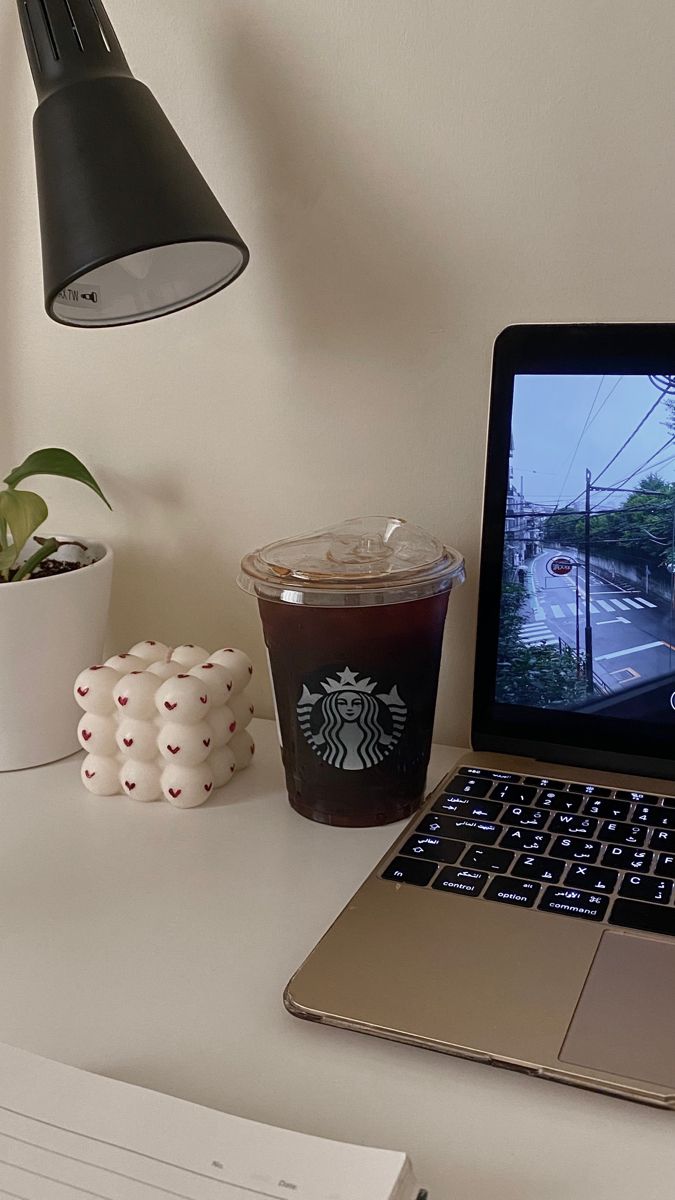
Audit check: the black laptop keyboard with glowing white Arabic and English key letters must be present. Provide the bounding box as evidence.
[382,767,675,937]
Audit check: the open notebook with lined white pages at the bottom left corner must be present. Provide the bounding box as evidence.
[0,1044,424,1200]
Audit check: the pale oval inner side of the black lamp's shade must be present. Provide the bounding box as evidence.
[50,241,244,326]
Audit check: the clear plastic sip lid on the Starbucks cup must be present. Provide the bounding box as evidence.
[238,517,465,607]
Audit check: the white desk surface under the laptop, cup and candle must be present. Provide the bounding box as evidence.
[0,721,675,1200]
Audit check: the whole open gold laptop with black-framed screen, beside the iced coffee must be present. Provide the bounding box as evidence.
[285,325,675,1109]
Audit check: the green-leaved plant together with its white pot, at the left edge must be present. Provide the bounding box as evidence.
[0,449,113,770]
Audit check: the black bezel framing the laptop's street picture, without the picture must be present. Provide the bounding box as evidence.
[472,324,675,779]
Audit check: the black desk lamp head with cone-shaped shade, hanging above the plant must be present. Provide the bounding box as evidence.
[18,0,249,328]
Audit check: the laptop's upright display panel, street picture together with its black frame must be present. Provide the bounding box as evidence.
[474,326,675,772]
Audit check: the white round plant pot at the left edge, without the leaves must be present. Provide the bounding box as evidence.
[0,539,113,770]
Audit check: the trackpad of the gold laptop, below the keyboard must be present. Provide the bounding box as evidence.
[560,932,675,1092]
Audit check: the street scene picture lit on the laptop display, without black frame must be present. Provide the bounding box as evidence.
[495,374,675,724]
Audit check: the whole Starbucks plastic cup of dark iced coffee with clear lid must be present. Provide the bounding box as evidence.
[238,517,464,826]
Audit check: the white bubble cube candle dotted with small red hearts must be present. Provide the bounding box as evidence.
[74,641,255,809]
